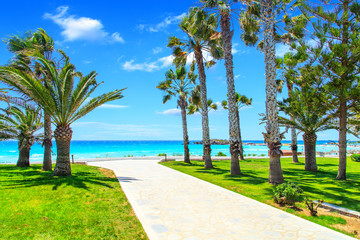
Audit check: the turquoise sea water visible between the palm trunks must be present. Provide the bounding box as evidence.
[0,140,352,163]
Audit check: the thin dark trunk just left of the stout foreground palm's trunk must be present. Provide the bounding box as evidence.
[42,112,52,171]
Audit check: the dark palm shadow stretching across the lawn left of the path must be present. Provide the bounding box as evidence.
[0,166,118,190]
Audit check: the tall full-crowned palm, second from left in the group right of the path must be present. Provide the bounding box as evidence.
[168,8,222,168]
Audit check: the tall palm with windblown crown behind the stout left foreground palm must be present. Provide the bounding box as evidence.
[7,28,55,171]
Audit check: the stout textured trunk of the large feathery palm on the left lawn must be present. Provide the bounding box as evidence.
[54,126,72,176]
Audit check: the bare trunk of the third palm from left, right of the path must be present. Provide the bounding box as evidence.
[220,12,241,175]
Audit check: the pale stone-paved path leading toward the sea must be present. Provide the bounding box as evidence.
[89,160,353,240]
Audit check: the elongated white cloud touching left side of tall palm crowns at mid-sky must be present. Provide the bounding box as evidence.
[122,55,174,72]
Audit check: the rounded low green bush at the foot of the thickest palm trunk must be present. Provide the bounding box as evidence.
[274,183,303,206]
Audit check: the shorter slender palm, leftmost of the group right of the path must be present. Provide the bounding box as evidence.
[156,64,197,163]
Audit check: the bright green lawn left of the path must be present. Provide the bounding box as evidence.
[0,164,148,239]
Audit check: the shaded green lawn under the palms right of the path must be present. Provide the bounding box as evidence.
[161,158,360,235]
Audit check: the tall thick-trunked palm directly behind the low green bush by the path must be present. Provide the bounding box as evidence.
[240,0,306,184]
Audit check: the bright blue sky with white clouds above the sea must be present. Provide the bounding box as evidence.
[0,0,344,140]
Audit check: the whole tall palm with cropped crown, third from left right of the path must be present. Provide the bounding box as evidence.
[200,0,241,175]
